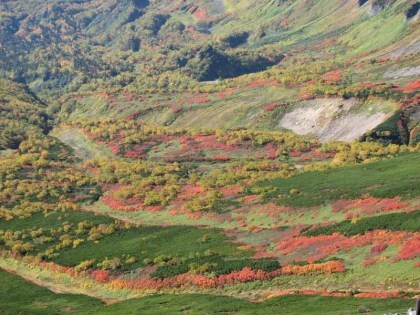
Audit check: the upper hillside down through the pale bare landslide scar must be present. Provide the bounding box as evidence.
[0,0,419,143]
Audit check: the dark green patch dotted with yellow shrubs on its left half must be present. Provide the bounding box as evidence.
[0,211,250,270]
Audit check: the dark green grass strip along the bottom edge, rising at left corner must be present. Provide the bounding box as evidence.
[0,270,415,315]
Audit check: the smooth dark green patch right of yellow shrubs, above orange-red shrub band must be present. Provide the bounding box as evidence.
[54,226,249,268]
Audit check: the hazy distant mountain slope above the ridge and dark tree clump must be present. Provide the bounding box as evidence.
[0,0,418,94]
